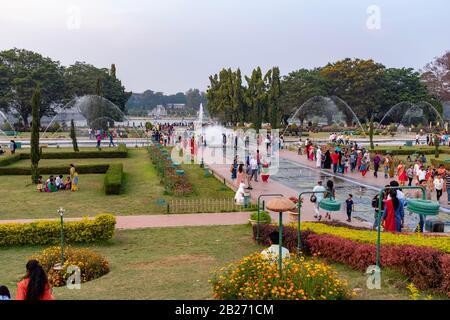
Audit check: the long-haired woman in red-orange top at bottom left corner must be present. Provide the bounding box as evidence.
[16,260,55,300]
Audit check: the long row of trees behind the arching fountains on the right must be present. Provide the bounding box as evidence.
[207,52,450,129]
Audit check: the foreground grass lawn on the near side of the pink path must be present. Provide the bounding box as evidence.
[0,225,439,299]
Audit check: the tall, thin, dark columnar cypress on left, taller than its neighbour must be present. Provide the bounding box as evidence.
[30,86,41,184]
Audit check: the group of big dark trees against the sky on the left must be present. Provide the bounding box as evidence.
[0,48,131,128]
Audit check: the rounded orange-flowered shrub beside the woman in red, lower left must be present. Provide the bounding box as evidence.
[30,246,109,287]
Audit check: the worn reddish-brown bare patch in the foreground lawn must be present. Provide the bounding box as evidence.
[128,254,216,270]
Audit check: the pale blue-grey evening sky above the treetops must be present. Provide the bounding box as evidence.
[0,0,450,93]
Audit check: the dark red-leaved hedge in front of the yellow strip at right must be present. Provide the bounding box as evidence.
[254,223,450,297]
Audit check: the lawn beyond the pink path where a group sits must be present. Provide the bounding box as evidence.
[0,148,234,220]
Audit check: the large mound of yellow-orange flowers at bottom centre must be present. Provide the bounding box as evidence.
[210,254,350,300]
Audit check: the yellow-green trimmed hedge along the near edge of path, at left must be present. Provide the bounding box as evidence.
[0,214,116,246]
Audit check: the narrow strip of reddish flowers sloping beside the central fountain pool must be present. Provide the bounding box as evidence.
[148,145,193,196]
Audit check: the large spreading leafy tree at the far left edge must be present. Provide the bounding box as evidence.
[0,49,64,127]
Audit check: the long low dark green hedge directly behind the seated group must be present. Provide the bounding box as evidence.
[0,164,110,176]
